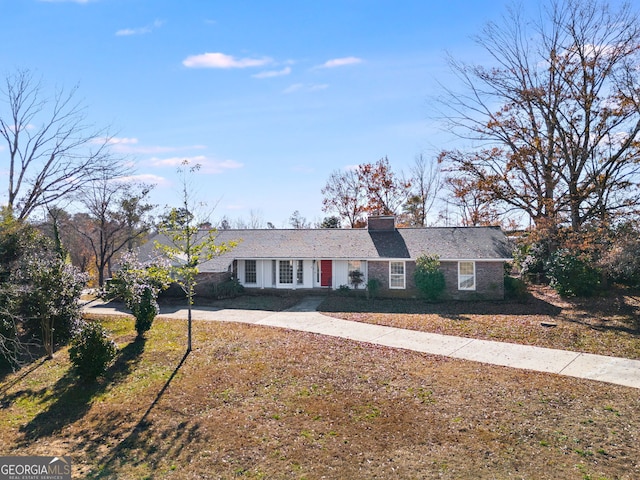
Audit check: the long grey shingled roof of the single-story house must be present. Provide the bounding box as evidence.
[144,227,511,272]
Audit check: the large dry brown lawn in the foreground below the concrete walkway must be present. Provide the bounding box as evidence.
[0,302,640,480]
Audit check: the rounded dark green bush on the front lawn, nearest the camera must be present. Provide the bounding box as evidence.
[69,322,118,380]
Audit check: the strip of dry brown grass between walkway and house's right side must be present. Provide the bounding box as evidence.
[320,286,640,359]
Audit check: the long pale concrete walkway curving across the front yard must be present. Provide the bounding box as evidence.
[85,297,640,388]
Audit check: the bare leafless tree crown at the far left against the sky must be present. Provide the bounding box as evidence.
[0,70,111,219]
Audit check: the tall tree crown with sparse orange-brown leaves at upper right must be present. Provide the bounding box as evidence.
[442,0,640,230]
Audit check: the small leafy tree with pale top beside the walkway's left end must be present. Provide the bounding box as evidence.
[106,253,170,338]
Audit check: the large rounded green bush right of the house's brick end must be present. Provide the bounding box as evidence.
[547,248,602,297]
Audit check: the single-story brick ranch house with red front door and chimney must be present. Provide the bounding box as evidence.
[147,216,511,299]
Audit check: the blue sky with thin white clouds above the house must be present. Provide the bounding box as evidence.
[0,0,512,227]
